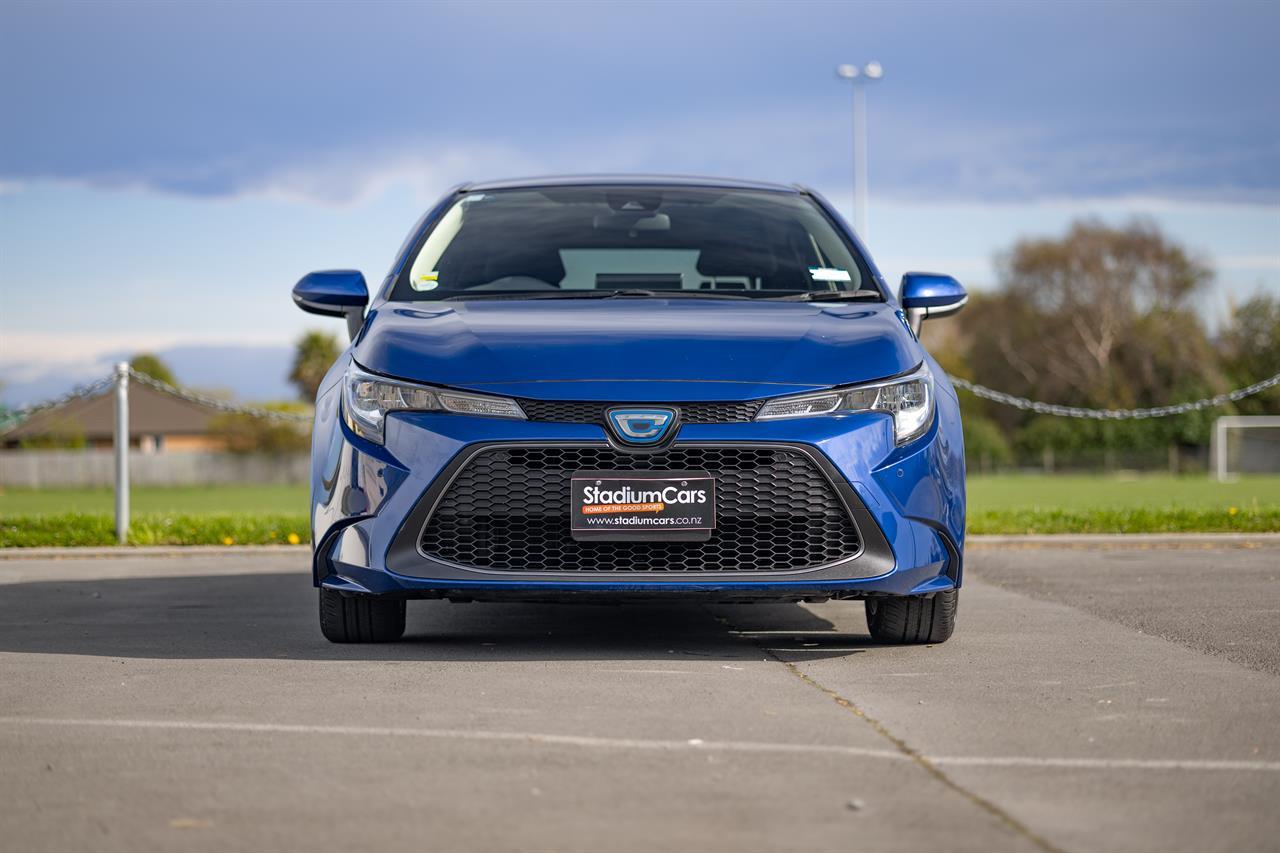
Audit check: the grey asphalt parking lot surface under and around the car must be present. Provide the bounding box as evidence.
[0,544,1280,852]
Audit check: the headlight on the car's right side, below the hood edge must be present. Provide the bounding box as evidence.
[755,365,933,444]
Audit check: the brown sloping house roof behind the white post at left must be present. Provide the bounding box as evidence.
[0,383,220,441]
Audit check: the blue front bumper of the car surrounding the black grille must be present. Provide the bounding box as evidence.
[312,381,964,601]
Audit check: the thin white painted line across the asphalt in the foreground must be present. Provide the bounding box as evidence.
[0,717,1264,772]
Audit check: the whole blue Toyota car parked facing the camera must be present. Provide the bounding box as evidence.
[293,177,966,643]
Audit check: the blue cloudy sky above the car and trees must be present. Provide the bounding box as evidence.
[0,3,1280,402]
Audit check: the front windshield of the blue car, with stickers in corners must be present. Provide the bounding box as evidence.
[390,186,882,301]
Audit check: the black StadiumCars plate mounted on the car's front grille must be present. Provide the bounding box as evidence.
[570,471,716,542]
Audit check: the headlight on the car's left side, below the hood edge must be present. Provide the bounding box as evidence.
[342,364,525,444]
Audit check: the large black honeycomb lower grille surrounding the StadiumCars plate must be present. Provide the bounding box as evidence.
[420,444,861,573]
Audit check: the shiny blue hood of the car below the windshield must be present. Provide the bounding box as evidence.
[352,298,924,402]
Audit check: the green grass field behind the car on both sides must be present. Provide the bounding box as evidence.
[0,474,1280,547]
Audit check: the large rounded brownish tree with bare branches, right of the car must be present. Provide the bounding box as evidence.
[979,220,1222,407]
